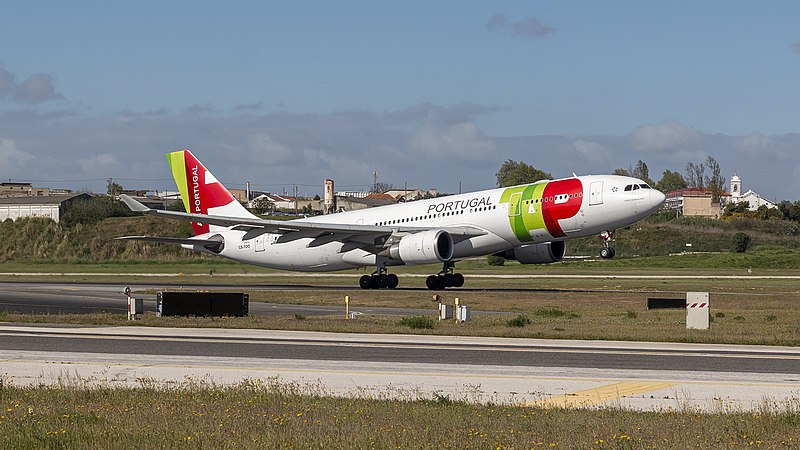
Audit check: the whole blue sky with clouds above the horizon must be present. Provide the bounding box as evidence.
[0,0,800,201]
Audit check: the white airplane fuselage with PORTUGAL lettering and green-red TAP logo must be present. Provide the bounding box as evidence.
[184,175,664,271]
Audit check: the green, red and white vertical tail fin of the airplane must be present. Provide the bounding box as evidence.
[167,150,256,235]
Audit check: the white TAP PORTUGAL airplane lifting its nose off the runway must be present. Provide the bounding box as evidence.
[116,150,665,290]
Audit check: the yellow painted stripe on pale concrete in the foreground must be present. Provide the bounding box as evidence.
[527,381,676,408]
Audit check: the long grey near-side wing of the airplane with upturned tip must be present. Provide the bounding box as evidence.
[119,194,486,252]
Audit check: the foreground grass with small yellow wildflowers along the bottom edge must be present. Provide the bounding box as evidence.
[0,379,800,449]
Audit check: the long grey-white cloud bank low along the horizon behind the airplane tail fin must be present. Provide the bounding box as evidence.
[0,104,800,200]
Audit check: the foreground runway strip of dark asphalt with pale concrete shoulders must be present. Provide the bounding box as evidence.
[0,324,800,411]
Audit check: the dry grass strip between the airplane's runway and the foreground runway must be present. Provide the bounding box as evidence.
[6,284,800,346]
